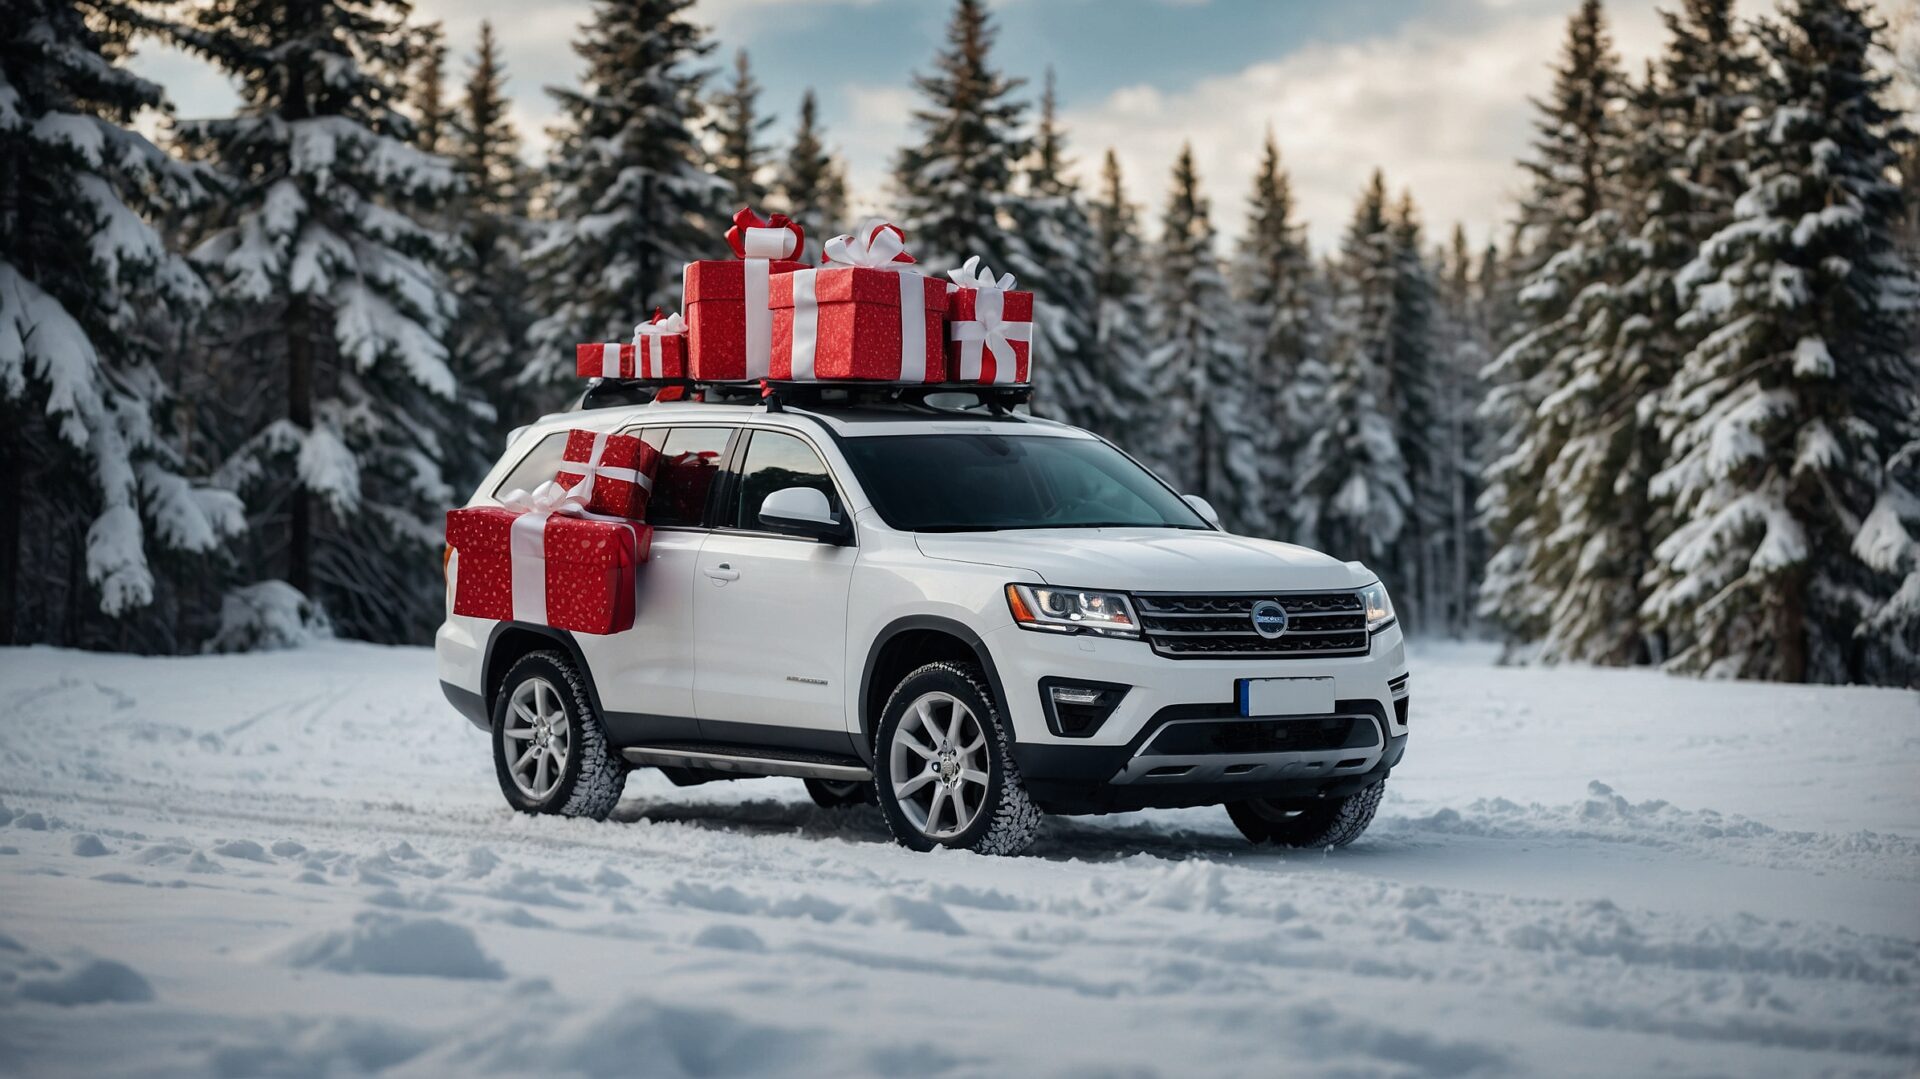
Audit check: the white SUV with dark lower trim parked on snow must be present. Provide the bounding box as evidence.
[436,392,1407,852]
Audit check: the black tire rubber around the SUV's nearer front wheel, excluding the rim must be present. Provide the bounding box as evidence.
[874,660,1041,854]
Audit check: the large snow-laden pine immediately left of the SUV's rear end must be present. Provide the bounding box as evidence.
[177,0,478,641]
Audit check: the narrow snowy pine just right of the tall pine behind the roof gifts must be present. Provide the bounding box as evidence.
[995,67,1114,426]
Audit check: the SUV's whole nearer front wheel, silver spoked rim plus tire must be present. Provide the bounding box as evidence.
[874,662,1041,854]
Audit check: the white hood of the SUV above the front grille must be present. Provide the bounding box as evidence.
[914,528,1375,591]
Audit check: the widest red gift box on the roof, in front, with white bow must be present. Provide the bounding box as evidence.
[772,225,947,382]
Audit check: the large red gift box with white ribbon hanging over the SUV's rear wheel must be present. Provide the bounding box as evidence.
[447,484,653,634]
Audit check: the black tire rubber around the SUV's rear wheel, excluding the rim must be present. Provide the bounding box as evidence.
[493,651,630,820]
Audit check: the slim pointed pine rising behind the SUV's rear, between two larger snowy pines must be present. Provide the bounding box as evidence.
[447,21,538,482]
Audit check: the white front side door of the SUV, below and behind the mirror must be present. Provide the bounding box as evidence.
[693,428,858,753]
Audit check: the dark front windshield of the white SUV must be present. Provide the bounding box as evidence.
[841,434,1208,532]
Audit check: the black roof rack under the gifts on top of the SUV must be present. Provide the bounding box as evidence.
[578,378,1033,415]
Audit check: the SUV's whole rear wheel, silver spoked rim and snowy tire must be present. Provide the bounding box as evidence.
[493,651,628,820]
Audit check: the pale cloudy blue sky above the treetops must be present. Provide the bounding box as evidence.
[138,0,1914,250]
